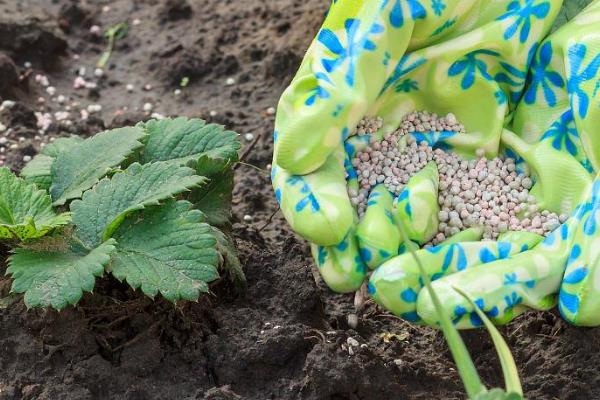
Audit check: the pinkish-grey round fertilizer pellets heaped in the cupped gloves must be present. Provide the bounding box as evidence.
[349,111,567,245]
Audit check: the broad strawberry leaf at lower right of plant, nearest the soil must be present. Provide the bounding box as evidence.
[110,200,219,302]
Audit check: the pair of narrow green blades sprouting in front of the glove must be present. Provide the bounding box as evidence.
[399,220,523,400]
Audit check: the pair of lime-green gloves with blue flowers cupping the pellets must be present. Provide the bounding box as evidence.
[272,0,600,327]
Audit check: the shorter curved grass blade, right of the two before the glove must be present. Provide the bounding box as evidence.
[453,286,523,396]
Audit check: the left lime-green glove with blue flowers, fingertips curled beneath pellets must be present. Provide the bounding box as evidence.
[272,0,561,292]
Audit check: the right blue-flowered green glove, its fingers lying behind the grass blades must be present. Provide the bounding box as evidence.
[369,1,600,328]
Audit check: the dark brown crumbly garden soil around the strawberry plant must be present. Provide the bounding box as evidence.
[0,0,600,400]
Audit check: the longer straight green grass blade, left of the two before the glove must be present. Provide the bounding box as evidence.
[398,223,486,398]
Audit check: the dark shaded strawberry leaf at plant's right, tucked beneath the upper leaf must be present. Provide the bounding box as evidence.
[189,156,233,226]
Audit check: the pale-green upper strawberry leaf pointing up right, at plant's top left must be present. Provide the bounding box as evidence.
[50,127,145,205]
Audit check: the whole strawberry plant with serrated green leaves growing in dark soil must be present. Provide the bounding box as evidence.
[0,118,244,310]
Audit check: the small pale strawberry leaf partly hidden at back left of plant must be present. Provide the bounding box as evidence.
[21,136,83,190]
